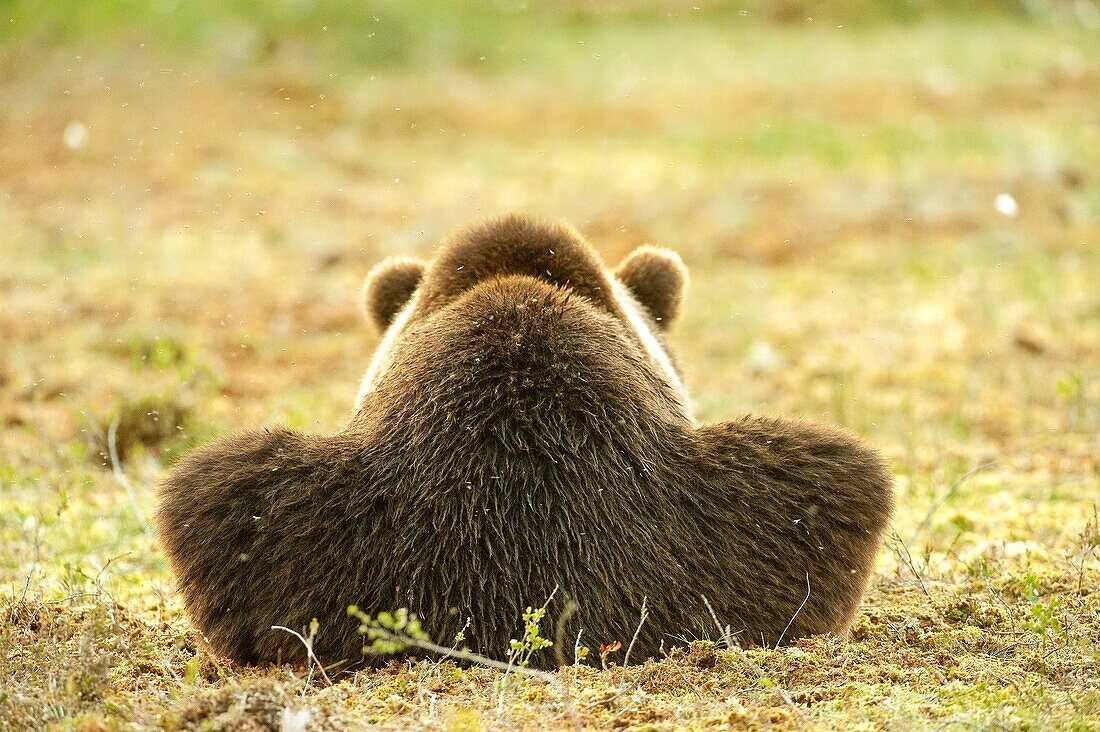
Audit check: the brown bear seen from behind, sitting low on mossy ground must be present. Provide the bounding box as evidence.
[156,216,892,665]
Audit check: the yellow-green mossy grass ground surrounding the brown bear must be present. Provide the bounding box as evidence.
[0,0,1100,730]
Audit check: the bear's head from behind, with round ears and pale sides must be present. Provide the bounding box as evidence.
[356,215,692,422]
